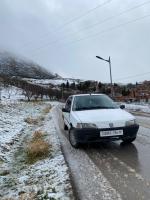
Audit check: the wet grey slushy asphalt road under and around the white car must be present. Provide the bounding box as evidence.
[54,108,150,200]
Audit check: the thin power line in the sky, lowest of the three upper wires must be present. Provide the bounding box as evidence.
[29,14,150,55]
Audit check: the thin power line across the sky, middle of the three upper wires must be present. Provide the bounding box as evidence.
[25,1,150,52]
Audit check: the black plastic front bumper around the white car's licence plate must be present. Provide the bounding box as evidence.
[73,124,139,143]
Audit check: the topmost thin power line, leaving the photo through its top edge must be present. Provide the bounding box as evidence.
[22,0,113,47]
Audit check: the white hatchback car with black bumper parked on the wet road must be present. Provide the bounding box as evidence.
[62,94,139,148]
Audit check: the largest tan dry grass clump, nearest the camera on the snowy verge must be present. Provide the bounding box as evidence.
[26,131,52,164]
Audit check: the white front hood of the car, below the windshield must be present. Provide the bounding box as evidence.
[74,108,135,128]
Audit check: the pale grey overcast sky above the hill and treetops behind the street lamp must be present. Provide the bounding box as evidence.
[0,0,150,83]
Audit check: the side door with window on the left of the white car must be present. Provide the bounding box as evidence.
[64,97,72,127]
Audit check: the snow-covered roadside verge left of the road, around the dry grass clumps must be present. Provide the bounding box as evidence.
[0,102,74,200]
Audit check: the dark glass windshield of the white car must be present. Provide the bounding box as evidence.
[72,95,118,111]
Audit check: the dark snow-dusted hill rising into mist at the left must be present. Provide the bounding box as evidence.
[0,52,57,79]
